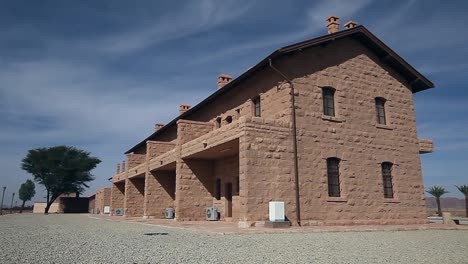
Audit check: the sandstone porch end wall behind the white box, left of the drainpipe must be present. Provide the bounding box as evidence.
[239,117,295,222]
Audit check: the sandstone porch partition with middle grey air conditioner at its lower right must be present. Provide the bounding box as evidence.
[144,171,176,218]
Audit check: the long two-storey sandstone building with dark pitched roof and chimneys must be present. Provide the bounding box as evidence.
[111,16,433,227]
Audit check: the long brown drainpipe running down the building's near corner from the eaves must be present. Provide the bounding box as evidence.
[269,58,301,226]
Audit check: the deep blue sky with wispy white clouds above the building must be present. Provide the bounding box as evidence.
[0,0,468,204]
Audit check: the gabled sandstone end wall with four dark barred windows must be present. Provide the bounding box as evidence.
[270,37,426,224]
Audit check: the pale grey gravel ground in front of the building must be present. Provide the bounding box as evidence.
[0,214,468,264]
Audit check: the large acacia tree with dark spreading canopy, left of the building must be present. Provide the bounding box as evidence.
[21,146,101,214]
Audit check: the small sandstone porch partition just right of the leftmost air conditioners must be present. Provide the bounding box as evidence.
[124,178,145,217]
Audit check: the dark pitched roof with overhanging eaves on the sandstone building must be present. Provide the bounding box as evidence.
[125,25,434,154]
